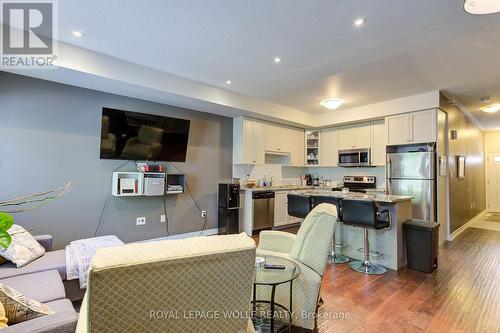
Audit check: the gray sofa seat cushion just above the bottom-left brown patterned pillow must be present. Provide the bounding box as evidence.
[0,270,66,303]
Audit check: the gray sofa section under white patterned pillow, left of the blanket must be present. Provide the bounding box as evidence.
[0,250,66,280]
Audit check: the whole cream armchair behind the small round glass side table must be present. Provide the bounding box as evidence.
[257,204,337,330]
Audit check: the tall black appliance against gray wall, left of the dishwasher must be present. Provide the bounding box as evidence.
[218,184,240,234]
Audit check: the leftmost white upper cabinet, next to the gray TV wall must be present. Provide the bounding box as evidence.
[233,117,264,164]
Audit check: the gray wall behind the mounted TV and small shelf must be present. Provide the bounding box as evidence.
[0,72,232,248]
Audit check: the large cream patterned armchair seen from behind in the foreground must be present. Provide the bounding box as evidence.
[76,234,255,333]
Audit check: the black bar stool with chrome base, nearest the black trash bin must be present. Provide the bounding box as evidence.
[342,199,391,275]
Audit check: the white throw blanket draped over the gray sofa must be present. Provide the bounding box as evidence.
[66,236,124,289]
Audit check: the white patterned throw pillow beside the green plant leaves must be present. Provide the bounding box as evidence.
[0,224,45,267]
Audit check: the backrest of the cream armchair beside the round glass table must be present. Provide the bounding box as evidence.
[290,203,337,276]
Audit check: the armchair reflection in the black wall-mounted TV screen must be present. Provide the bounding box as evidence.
[122,125,163,161]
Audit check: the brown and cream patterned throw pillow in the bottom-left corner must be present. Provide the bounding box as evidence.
[0,284,54,324]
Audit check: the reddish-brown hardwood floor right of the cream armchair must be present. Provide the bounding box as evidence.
[258,228,500,333]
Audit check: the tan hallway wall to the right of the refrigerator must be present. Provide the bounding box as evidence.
[440,95,486,233]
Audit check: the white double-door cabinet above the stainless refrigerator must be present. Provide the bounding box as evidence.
[385,110,437,145]
